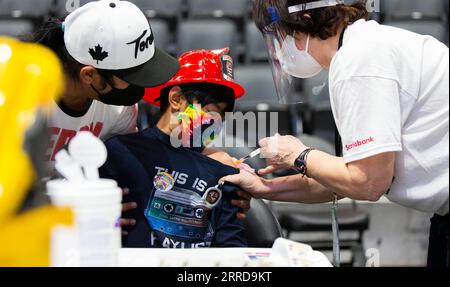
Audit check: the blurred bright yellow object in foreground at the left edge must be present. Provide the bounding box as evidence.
[0,37,71,266]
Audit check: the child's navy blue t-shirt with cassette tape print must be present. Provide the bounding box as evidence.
[100,127,247,248]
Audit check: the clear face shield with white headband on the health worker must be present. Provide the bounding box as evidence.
[263,0,342,104]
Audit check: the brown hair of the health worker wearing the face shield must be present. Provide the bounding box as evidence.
[253,0,369,40]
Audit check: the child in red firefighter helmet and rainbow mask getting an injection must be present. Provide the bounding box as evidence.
[101,49,246,248]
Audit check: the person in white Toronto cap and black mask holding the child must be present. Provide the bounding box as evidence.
[34,0,179,162]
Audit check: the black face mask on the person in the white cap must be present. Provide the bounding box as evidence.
[91,84,145,106]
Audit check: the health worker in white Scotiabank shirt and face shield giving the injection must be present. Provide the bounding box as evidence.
[224,0,450,267]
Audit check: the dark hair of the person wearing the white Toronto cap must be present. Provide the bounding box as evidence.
[32,18,113,84]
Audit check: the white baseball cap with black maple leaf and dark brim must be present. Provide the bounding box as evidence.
[64,0,179,87]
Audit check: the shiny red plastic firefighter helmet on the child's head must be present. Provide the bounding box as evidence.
[144,48,245,106]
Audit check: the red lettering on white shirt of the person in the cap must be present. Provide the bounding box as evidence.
[44,122,103,161]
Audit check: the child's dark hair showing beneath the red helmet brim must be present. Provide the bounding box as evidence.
[160,83,235,114]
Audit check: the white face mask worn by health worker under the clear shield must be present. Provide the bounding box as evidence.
[275,35,323,79]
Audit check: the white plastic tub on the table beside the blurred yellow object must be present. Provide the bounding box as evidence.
[47,180,122,267]
